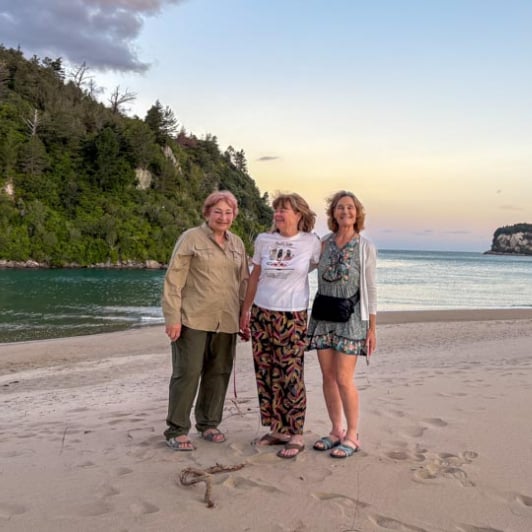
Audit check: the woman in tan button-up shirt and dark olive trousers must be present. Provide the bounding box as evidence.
[162,191,249,451]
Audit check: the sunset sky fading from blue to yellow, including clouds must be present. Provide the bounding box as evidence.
[0,0,532,251]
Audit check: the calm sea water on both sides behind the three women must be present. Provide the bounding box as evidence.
[0,250,532,342]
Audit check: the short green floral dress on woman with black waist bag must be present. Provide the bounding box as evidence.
[307,235,368,355]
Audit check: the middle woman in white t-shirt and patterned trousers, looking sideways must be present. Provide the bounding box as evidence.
[240,193,321,458]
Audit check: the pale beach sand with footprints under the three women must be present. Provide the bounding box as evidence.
[0,310,532,532]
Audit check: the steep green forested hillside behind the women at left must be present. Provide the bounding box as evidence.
[0,46,271,267]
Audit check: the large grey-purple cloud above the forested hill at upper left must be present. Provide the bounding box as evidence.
[0,0,184,72]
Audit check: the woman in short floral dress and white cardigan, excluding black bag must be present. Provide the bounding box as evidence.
[307,190,377,458]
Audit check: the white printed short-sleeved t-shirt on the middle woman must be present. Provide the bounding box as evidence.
[253,232,321,312]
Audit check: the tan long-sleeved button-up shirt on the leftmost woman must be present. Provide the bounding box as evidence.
[162,223,249,333]
